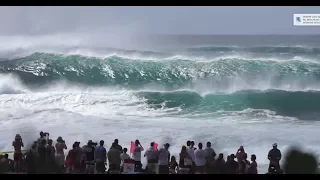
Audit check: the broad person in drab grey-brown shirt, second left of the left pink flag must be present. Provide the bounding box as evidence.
[108,143,121,174]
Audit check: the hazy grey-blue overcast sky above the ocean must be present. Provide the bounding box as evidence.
[0,6,320,35]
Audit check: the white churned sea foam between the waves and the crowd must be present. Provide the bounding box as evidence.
[0,75,320,172]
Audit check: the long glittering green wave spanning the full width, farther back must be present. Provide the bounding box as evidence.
[0,53,320,91]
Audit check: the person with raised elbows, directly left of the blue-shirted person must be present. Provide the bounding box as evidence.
[83,140,97,174]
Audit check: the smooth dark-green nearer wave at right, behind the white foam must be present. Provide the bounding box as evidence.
[137,90,320,120]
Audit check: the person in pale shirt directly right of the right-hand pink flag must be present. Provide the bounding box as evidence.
[158,143,170,174]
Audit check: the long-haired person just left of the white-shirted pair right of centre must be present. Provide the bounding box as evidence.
[179,146,192,174]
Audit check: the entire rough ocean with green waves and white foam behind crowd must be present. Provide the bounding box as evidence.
[0,35,320,173]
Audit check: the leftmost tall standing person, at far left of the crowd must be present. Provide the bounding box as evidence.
[12,134,24,172]
